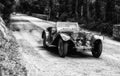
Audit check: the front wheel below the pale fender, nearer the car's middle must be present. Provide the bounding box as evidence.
[58,39,68,57]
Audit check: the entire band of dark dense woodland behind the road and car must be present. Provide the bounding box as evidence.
[0,0,120,34]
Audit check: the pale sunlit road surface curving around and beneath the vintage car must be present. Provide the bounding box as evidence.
[11,14,120,76]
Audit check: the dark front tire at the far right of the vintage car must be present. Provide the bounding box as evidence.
[92,41,102,58]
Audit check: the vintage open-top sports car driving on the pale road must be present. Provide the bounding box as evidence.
[42,22,103,58]
